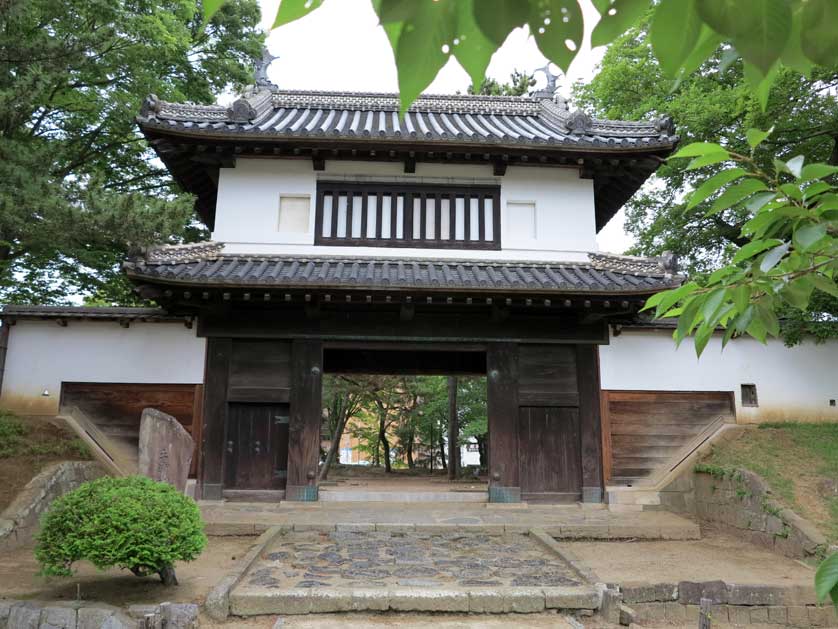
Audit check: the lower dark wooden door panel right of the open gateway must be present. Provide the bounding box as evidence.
[518,406,582,500]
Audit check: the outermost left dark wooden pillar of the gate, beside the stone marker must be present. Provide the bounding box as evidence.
[197,337,233,500]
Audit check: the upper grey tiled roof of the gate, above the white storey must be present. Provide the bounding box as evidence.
[139,89,678,151]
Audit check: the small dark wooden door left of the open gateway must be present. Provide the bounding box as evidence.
[224,402,289,490]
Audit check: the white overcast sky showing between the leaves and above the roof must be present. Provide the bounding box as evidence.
[259,0,632,253]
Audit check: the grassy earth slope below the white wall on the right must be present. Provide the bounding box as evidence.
[704,422,838,542]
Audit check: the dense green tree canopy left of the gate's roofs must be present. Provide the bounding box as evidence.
[0,0,265,304]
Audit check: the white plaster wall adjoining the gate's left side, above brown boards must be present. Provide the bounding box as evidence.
[0,319,206,415]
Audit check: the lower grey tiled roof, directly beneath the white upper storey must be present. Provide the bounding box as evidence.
[125,243,681,294]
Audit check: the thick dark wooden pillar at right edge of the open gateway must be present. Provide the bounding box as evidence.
[486,343,521,502]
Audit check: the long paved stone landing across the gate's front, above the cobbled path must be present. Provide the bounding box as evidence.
[200,501,700,539]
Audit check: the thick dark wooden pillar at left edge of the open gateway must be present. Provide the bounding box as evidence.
[285,340,323,501]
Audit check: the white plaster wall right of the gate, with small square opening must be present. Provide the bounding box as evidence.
[600,329,838,423]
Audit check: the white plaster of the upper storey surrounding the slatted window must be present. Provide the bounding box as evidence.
[212,159,597,261]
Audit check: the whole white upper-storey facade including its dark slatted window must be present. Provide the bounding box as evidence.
[212,158,597,261]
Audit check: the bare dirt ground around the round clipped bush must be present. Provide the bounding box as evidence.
[0,537,256,607]
